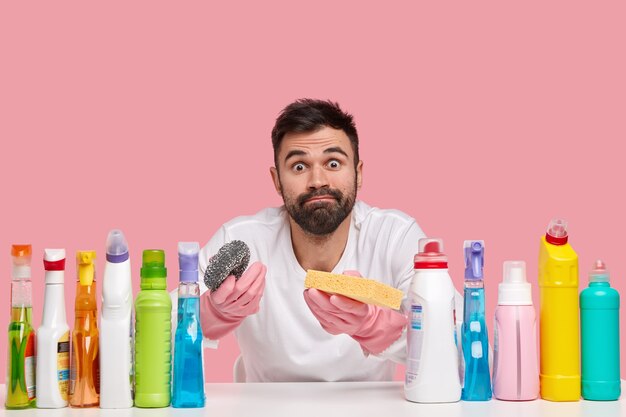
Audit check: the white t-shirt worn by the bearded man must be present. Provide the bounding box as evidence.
[193,201,458,382]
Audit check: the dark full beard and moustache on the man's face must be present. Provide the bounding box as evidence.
[281,182,356,236]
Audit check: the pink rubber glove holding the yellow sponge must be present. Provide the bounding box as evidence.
[304,271,407,354]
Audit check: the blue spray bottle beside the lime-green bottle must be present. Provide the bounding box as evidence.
[172,242,204,408]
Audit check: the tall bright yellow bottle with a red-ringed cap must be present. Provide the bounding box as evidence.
[539,219,580,401]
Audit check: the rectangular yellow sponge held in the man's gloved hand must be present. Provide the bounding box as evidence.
[304,269,404,310]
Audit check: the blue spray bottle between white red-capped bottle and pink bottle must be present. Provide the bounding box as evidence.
[461,240,491,401]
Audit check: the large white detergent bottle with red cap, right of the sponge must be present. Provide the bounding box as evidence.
[404,238,461,403]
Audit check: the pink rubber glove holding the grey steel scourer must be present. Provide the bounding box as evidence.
[200,262,267,340]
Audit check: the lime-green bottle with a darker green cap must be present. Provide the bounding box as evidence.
[135,250,172,407]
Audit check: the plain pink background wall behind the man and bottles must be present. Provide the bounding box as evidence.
[0,1,626,381]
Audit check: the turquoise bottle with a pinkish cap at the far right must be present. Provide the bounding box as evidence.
[580,260,621,401]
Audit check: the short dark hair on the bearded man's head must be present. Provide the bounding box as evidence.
[272,98,359,168]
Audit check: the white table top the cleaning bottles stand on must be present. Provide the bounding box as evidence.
[0,381,626,417]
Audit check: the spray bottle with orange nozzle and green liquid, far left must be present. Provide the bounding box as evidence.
[5,245,36,409]
